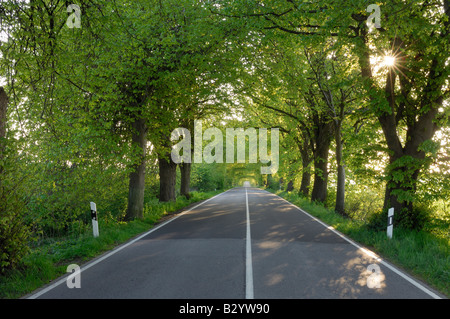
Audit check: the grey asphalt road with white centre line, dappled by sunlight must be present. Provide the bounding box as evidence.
[29,188,441,299]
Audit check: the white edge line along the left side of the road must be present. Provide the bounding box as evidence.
[26,188,233,299]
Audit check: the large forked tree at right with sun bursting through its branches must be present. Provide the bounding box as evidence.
[216,0,450,227]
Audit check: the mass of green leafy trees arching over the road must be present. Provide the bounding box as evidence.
[0,0,450,276]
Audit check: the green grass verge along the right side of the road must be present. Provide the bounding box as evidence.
[276,192,450,296]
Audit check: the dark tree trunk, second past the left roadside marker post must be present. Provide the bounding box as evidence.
[158,153,177,202]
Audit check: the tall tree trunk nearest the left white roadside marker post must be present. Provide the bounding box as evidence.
[125,119,147,220]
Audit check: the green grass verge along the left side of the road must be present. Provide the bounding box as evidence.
[0,191,220,299]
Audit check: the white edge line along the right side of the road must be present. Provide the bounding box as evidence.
[265,191,442,299]
